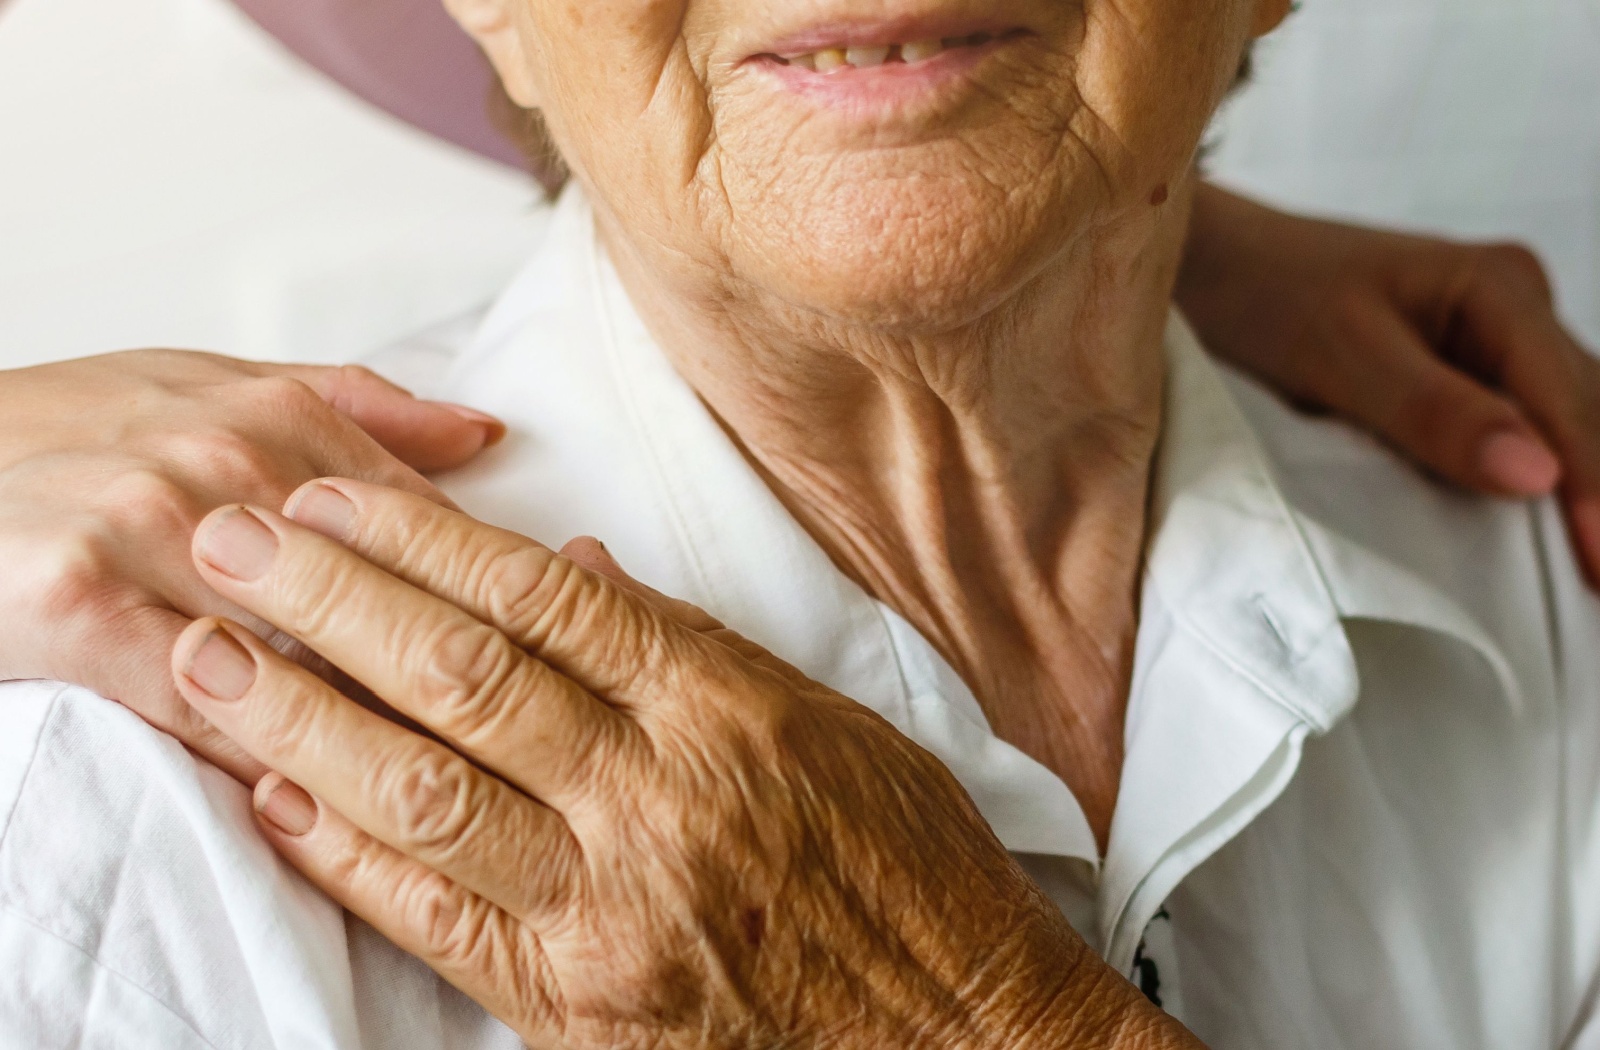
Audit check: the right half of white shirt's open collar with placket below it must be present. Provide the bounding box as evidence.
[1098,314,1514,965]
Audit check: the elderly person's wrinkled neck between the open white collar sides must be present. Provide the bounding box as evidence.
[602,184,1186,848]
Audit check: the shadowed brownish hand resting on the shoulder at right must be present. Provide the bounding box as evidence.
[1178,187,1600,586]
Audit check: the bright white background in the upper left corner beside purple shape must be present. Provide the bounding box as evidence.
[0,0,536,363]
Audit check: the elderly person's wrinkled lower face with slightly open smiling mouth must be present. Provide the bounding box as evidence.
[451,0,1288,330]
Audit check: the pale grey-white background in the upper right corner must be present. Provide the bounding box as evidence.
[1213,0,1600,351]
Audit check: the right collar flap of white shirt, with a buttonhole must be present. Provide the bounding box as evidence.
[1146,312,1522,731]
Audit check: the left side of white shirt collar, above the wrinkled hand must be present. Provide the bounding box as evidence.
[440,189,1096,863]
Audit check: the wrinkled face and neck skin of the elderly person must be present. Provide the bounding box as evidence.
[450,0,1288,844]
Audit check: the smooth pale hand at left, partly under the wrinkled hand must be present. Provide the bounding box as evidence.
[0,351,499,776]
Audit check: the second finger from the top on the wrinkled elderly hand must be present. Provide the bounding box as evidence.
[195,496,638,810]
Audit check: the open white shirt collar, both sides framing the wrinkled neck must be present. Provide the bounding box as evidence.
[445,190,1523,911]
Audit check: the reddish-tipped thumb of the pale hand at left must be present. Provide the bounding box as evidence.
[278,365,506,474]
